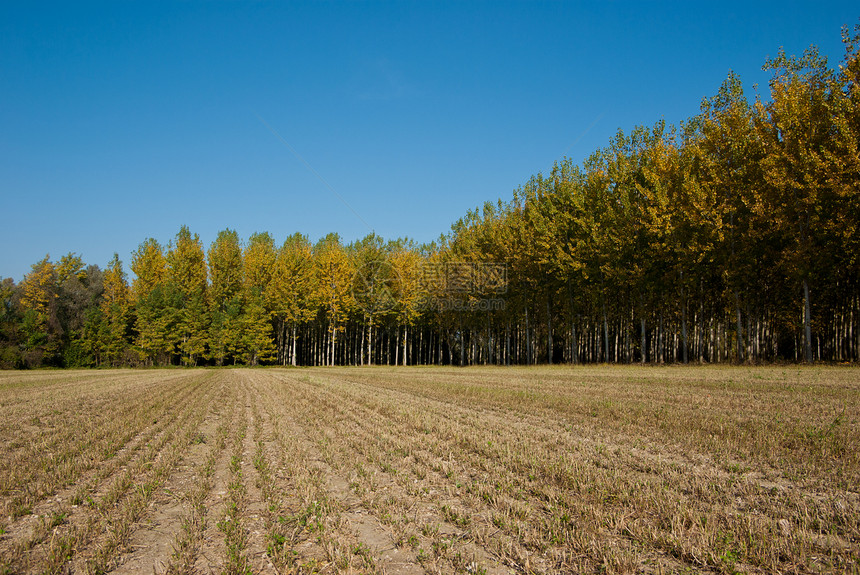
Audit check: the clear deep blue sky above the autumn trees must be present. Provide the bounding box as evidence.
[0,1,860,281]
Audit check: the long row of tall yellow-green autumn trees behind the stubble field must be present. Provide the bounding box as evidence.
[0,27,860,367]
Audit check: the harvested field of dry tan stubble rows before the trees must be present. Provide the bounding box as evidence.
[0,366,860,574]
